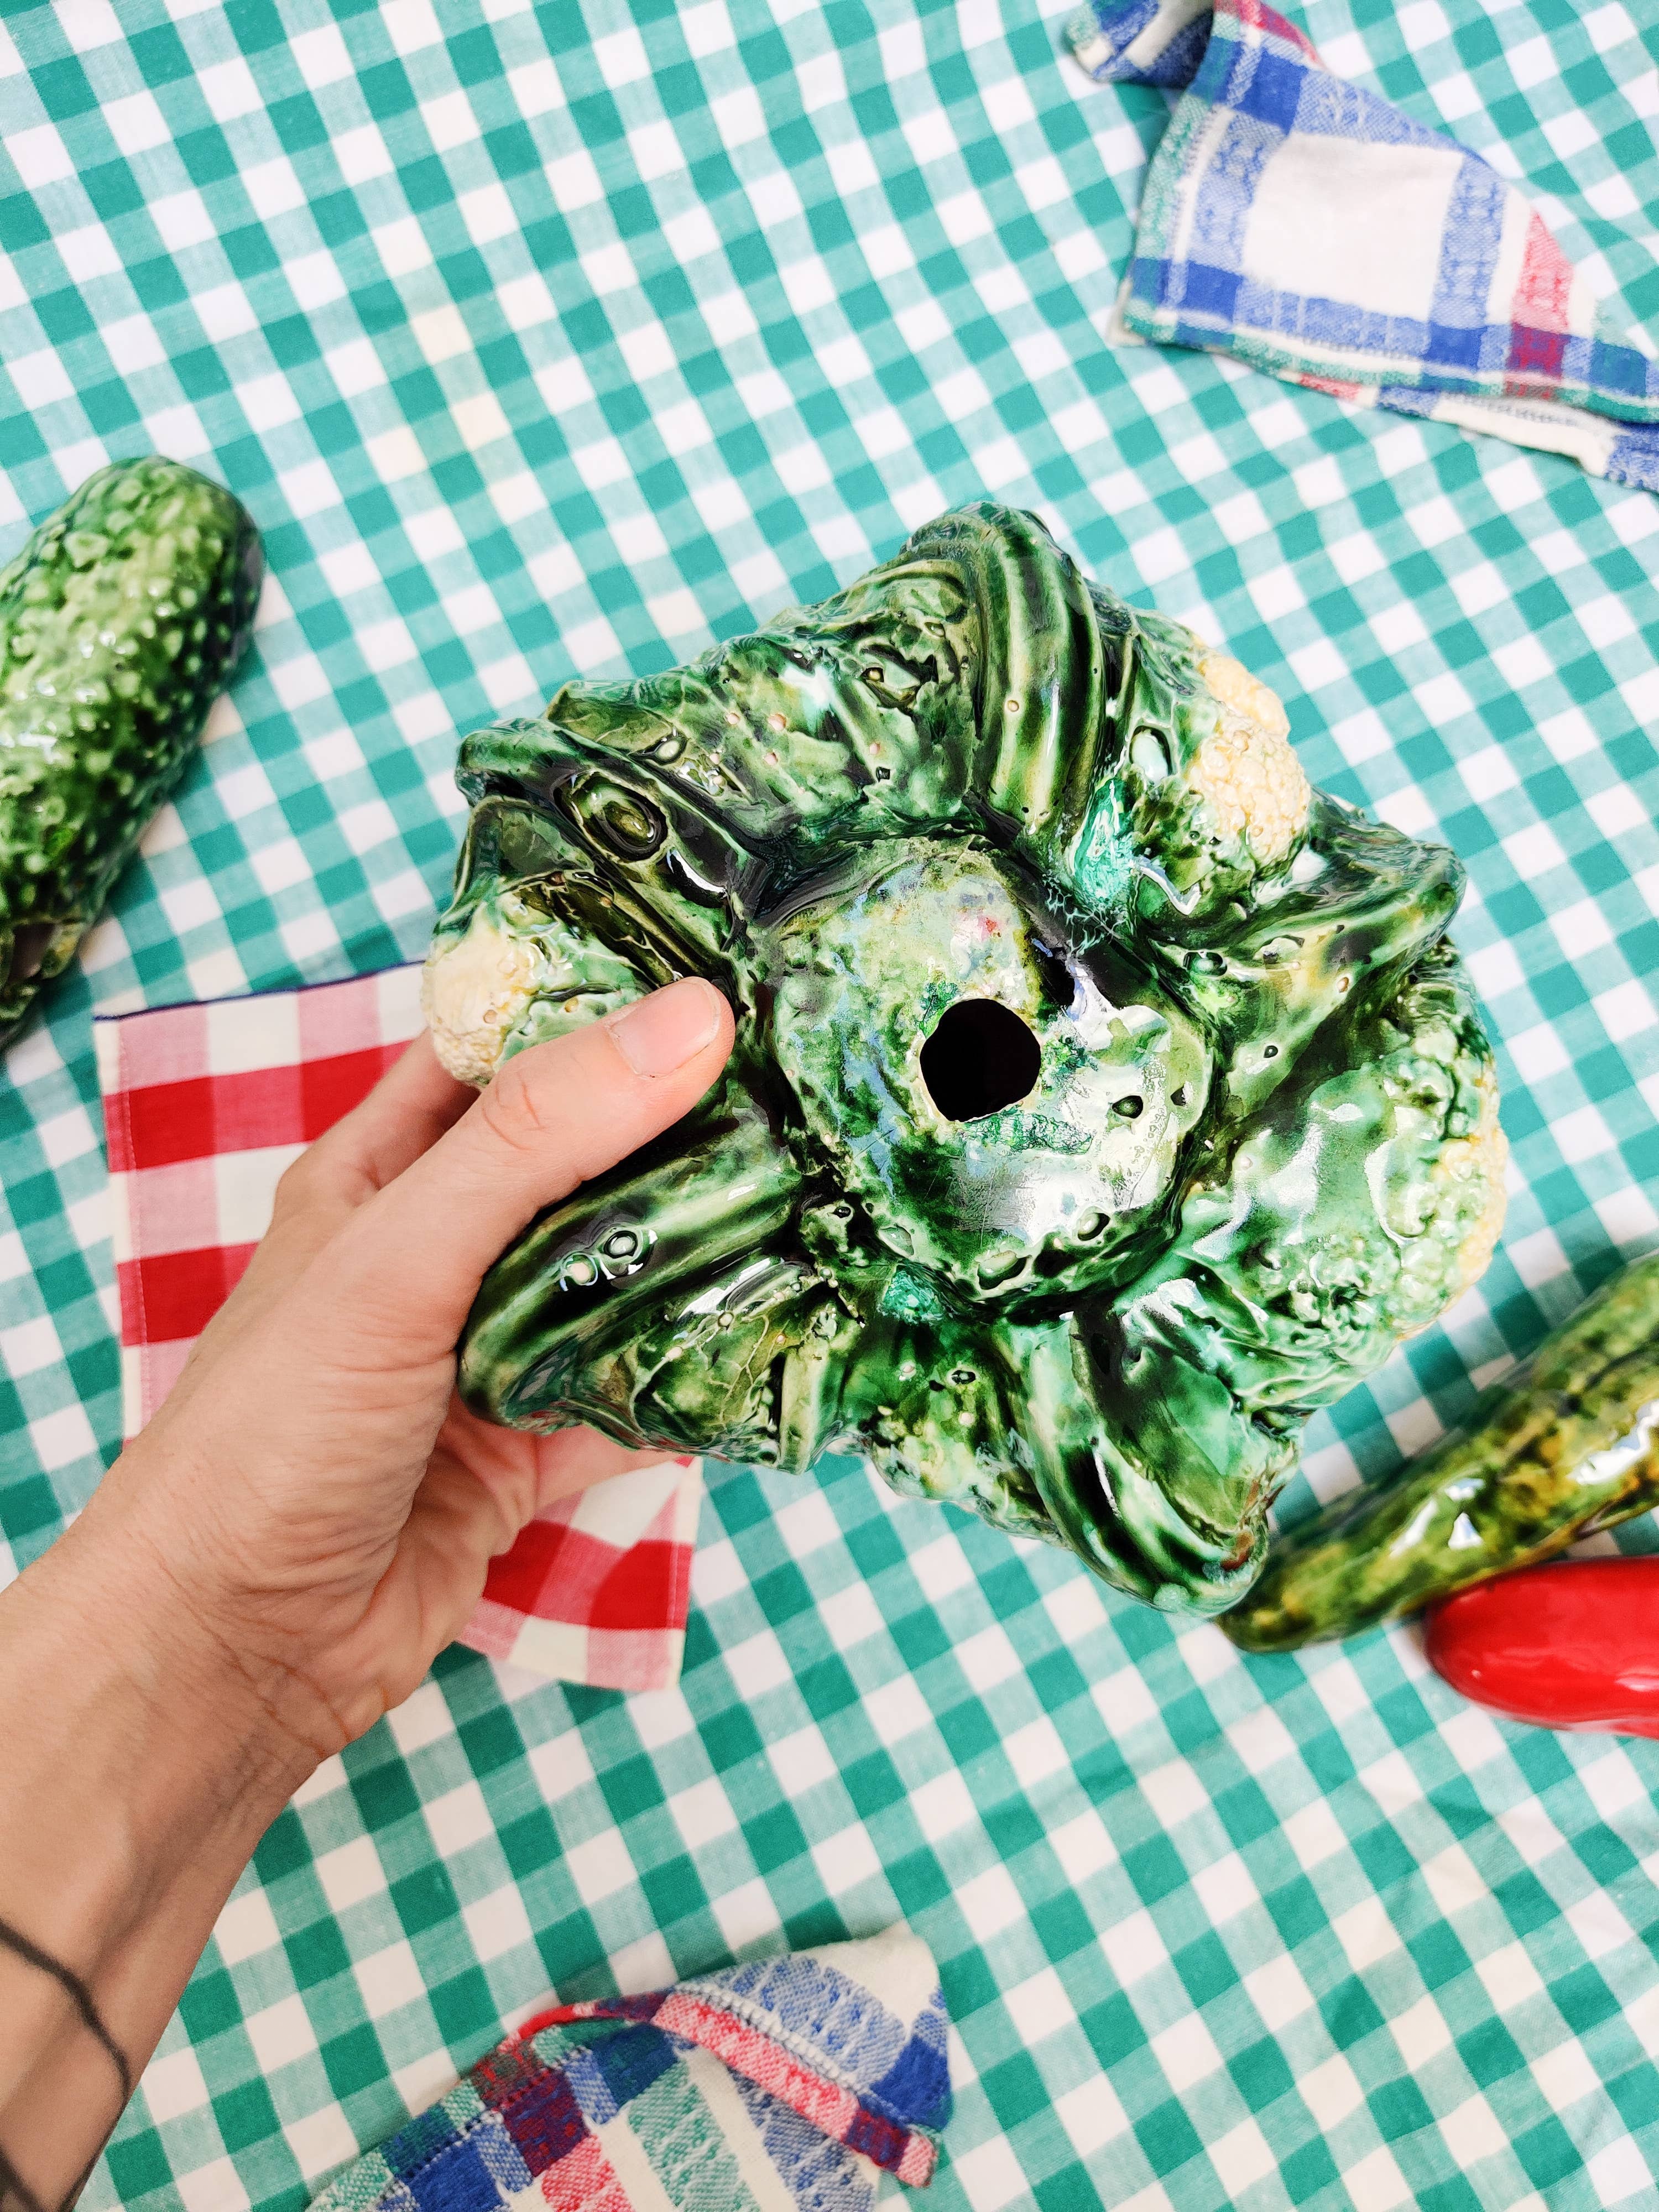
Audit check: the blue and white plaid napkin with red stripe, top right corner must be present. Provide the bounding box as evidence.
[1066,0,1659,491]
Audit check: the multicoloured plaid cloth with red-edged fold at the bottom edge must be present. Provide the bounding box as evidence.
[312,1929,951,2212]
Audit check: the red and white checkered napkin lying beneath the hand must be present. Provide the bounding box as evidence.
[93,967,703,1690]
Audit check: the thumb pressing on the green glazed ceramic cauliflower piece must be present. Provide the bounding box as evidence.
[316,975,732,1365]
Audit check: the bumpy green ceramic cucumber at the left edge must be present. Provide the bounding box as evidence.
[0,460,263,1046]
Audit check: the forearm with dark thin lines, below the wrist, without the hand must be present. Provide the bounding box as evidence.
[0,1506,312,2212]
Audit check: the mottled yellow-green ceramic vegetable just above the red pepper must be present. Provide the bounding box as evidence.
[1221,1254,1659,1652]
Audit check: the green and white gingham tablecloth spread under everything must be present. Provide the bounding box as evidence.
[0,0,1659,2212]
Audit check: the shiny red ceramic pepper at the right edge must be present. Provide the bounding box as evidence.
[1425,1557,1659,1736]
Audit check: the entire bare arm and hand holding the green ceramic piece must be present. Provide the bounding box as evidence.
[0,980,732,2212]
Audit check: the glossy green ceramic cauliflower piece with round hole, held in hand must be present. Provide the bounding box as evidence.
[427,504,1504,1613]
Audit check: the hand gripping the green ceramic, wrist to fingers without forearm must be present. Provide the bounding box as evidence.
[71,980,732,1761]
